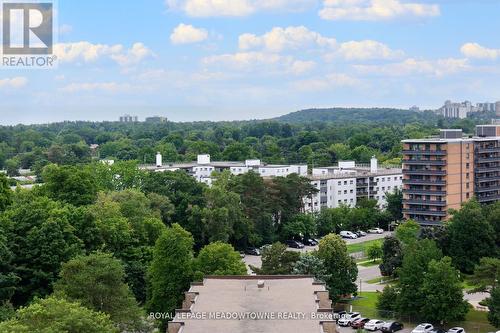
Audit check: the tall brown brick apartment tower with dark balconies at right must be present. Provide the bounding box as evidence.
[403,125,500,225]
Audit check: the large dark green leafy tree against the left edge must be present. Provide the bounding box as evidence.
[0,191,83,306]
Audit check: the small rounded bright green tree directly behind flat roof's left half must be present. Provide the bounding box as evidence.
[194,242,247,278]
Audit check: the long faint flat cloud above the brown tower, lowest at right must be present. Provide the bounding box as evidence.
[354,58,470,77]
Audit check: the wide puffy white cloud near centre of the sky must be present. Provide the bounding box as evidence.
[238,26,336,52]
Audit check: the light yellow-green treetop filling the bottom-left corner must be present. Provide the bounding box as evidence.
[0,297,119,333]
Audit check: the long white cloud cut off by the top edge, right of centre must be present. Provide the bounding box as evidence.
[319,0,440,21]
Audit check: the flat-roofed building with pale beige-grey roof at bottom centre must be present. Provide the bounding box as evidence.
[167,275,336,333]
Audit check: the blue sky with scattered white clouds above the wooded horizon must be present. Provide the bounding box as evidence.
[0,0,500,125]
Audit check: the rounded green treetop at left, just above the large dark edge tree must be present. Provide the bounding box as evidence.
[42,165,97,206]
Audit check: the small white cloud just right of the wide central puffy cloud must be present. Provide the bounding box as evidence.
[336,40,404,60]
